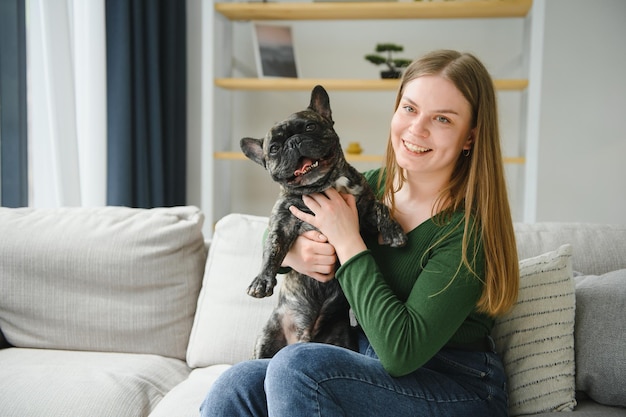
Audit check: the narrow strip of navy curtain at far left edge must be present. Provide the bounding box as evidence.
[0,0,28,207]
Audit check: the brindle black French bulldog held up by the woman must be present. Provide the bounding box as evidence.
[240,85,406,358]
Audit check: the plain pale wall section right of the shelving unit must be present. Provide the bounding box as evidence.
[537,0,626,223]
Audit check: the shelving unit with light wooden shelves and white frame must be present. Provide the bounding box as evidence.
[209,0,533,228]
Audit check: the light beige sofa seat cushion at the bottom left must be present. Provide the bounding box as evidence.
[0,348,189,417]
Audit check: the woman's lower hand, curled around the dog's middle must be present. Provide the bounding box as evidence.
[283,230,337,282]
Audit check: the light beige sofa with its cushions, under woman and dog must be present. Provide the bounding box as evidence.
[0,207,626,417]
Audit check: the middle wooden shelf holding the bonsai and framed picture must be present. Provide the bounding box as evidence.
[215,78,528,91]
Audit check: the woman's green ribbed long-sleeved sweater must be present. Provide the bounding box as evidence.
[336,170,493,376]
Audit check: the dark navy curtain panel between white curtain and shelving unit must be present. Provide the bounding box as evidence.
[106,0,187,208]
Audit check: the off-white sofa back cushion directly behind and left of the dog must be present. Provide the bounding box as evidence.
[187,214,279,368]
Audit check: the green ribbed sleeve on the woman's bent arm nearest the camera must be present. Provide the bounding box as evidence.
[336,219,483,376]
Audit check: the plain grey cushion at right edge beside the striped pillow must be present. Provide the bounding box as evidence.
[575,269,626,407]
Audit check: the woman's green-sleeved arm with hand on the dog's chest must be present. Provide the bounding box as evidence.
[291,189,484,376]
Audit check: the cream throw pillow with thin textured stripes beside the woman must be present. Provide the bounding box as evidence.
[493,245,576,416]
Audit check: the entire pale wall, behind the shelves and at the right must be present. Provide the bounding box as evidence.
[189,0,626,223]
